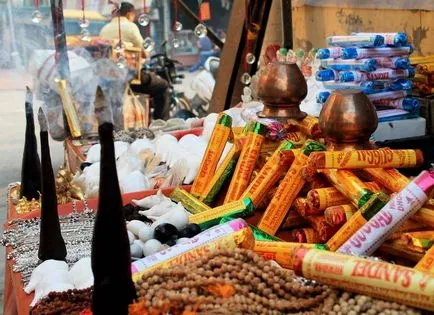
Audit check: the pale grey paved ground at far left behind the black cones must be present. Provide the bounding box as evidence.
[0,70,63,313]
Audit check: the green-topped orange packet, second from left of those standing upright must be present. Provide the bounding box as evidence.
[224,122,267,203]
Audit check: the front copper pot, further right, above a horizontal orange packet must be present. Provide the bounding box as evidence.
[319,90,378,150]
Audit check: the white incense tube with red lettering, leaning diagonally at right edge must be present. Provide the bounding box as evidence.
[338,171,434,255]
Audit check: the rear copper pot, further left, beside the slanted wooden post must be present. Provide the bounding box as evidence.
[258,61,307,121]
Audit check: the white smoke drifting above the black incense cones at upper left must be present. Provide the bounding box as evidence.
[0,4,132,141]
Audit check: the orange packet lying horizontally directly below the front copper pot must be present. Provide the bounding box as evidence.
[309,149,423,169]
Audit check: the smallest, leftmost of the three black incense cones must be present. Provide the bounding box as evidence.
[20,87,41,201]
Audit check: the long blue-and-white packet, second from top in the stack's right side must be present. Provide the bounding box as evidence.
[342,46,413,59]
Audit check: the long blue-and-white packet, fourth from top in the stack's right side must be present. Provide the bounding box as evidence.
[340,68,416,82]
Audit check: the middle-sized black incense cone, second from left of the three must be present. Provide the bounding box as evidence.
[38,108,66,261]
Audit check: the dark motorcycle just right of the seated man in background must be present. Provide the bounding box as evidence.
[147,40,192,117]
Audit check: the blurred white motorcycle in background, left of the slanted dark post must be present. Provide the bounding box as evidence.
[191,57,220,117]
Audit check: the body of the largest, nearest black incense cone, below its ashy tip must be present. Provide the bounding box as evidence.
[92,123,136,315]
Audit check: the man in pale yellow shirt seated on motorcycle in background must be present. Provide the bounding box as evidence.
[100,2,170,120]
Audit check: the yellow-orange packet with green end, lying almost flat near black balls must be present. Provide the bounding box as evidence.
[188,198,255,229]
